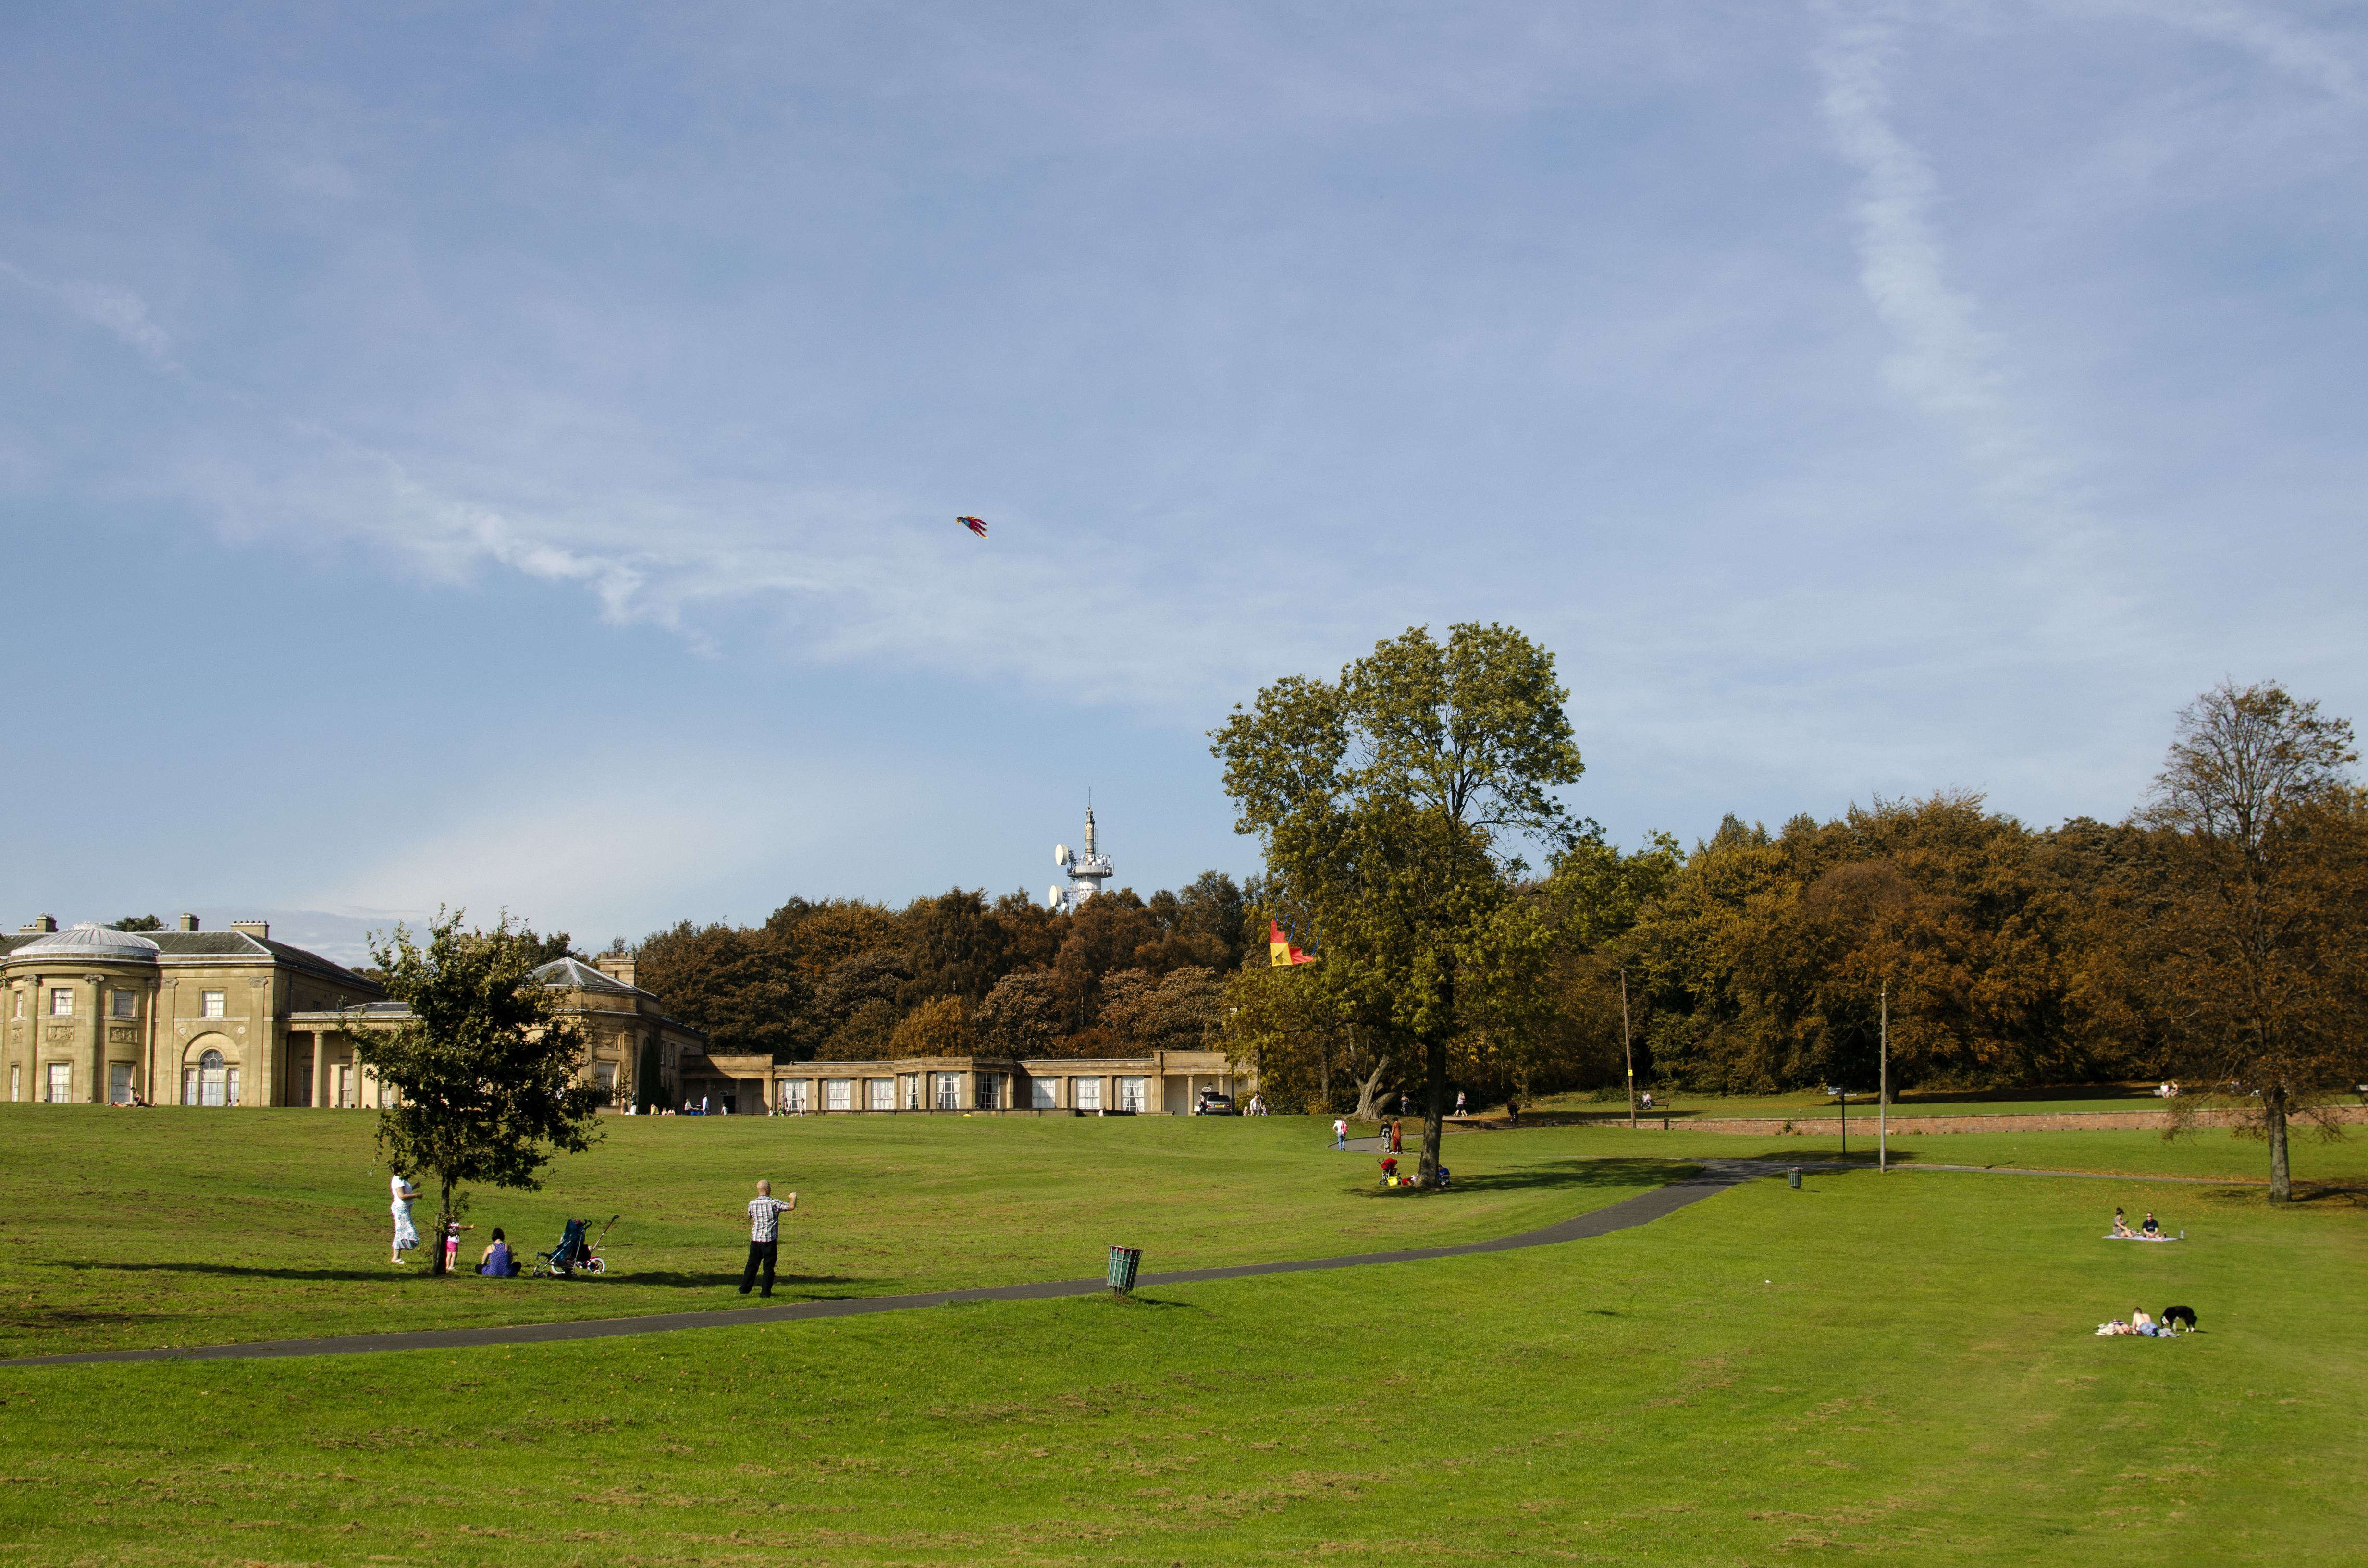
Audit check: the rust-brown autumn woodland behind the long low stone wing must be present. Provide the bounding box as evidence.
[632,871,1265,1061]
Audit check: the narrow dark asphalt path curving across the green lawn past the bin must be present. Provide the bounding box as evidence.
[0,1160,1809,1367]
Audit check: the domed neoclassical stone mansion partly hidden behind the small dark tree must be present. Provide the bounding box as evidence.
[0,914,708,1108]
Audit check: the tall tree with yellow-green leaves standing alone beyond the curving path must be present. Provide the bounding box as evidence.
[1210,623,1582,1184]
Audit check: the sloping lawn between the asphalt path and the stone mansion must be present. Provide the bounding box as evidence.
[0,1104,1672,1355]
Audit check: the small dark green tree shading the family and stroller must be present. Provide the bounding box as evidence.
[350,909,602,1274]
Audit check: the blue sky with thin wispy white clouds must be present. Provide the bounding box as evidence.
[0,0,2368,952]
